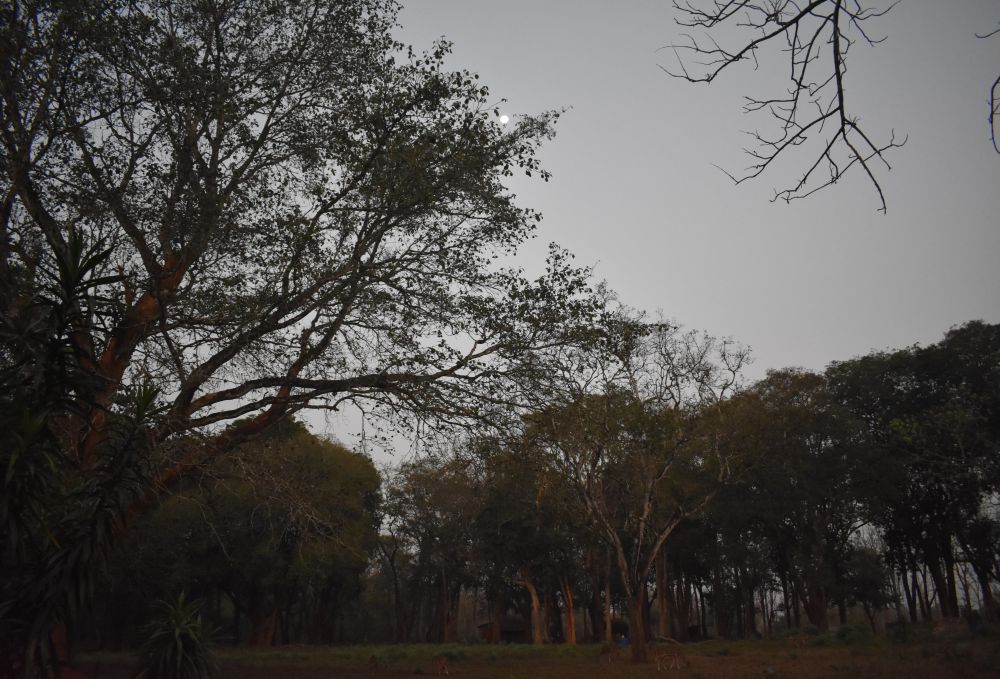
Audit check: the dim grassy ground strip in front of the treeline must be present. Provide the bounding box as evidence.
[77,639,1000,679]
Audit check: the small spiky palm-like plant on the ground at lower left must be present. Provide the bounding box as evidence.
[139,592,217,679]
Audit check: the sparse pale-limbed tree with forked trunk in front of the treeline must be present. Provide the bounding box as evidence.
[527,320,747,662]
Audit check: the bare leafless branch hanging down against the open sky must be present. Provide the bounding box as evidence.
[661,0,906,212]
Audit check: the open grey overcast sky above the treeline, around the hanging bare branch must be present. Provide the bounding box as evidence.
[398,0,1000,378]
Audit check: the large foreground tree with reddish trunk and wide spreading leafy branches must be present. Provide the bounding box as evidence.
[0,0,591,668]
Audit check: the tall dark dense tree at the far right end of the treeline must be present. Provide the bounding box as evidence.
[827,321,1000,617]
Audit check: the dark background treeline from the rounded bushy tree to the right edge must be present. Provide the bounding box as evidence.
[370,323,1000,653]
